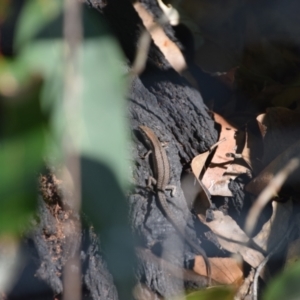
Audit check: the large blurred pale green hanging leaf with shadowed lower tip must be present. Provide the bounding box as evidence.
[14,4,134,299]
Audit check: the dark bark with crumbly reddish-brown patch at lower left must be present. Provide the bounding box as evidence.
[8,172,118,300]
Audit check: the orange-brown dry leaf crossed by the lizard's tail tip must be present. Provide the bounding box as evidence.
[193,255,243,285]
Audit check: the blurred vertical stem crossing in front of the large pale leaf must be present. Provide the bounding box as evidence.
[63,0,83,300]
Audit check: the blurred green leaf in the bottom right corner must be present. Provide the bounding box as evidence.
[263,261,300,300]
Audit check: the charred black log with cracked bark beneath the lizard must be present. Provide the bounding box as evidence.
[86,0,217,297]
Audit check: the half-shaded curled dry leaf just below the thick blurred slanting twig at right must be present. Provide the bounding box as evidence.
[253,200,293,252]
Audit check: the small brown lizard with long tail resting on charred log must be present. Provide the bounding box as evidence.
[139,126,211,285]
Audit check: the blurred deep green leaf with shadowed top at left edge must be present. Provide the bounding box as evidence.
[0,82,47,233]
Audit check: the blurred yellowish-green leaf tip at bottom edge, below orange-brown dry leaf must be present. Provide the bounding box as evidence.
[186,287,235,300]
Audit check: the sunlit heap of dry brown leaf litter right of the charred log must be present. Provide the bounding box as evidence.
[191,102,300,287]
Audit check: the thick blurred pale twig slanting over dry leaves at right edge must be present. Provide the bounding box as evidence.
[245,158,300,237]
